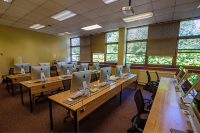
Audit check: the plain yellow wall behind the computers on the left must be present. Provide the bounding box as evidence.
[0,25,70,75]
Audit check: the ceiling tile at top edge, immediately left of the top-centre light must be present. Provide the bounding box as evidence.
[81,0,105,10]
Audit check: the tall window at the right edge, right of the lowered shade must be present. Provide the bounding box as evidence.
[176,20,200,66]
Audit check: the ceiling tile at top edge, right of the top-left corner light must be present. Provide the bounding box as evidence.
[13,0,38,10]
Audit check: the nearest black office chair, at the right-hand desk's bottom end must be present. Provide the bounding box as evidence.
[127,89,149,132]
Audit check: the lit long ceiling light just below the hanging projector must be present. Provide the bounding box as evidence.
[123,12,153,22]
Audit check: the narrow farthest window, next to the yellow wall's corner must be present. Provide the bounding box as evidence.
[71,38,80,61]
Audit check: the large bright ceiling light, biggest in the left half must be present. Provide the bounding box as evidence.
[51,10,77,21]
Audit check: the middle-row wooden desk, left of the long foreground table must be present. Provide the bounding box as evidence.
[20,76,71,112]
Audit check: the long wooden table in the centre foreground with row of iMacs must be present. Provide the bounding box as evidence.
[48,74,137,132]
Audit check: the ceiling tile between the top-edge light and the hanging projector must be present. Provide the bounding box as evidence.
[107,0,129,12]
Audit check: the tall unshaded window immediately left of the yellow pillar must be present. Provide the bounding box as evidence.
[106,31,119,62]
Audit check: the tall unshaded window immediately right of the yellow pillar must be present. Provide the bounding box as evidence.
[126,26,148,64]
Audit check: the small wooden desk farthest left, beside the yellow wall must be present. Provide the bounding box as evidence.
[6,73,31,96]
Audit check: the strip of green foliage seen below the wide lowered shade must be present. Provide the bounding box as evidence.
[148,56,173,65]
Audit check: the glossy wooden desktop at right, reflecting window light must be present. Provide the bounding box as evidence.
[144,77,189,133]
